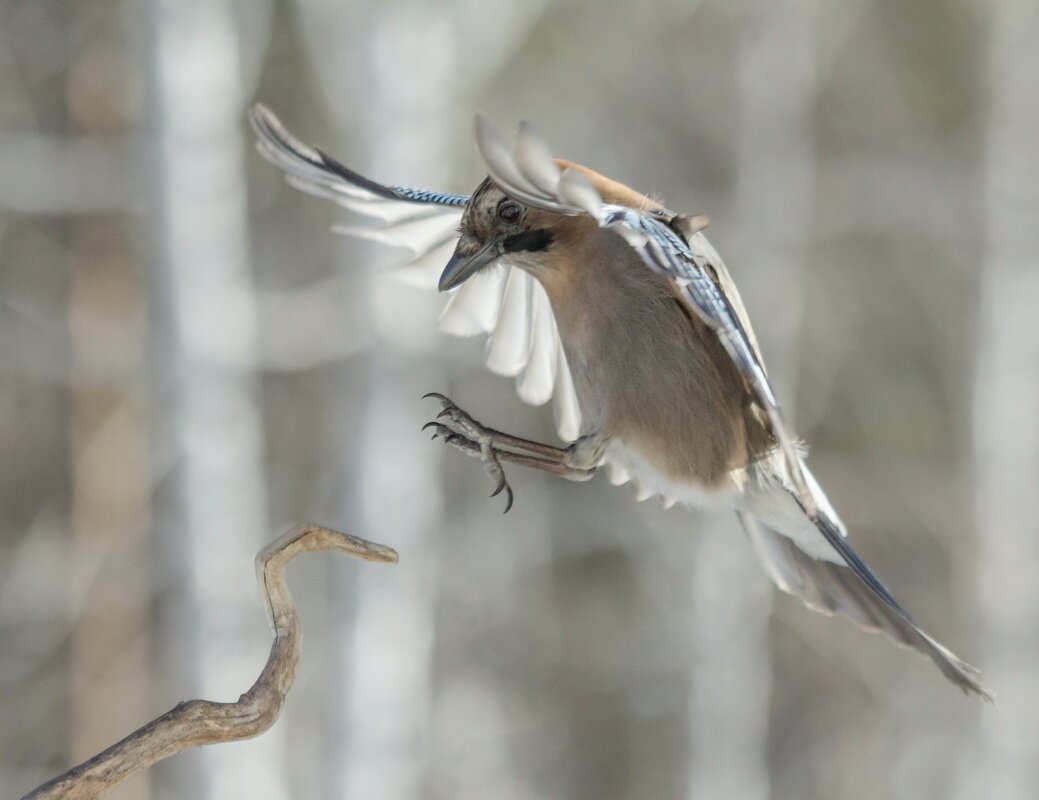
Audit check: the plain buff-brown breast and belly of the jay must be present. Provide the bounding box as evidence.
[539,217,770,488]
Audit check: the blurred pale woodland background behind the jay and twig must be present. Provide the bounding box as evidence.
[0,0,1039,800]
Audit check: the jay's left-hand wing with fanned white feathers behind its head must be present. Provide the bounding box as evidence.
[249,105,581,442]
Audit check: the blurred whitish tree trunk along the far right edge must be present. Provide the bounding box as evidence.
[964,0,1039,800]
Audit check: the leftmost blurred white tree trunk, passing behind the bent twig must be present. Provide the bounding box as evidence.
[148,0,276,800]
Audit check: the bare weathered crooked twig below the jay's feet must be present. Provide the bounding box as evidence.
[22,525,397,800]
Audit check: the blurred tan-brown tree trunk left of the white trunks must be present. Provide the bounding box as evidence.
[68,73,153,800]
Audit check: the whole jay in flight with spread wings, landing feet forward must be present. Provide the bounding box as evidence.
[249,105,991,699]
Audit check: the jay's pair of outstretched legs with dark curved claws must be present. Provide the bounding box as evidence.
[423,392,602,511]
